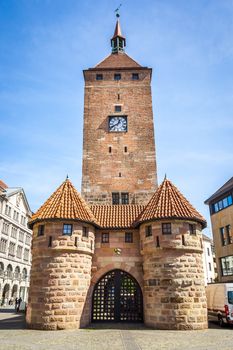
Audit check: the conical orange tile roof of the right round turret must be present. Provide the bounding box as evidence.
[138,178,206,227]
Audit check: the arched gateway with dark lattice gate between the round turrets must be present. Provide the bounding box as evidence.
[92,270,143,322]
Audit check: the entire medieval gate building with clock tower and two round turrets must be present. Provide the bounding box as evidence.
[27,21,207,330]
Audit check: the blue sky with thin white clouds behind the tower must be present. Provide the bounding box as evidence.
[0,0,233,233]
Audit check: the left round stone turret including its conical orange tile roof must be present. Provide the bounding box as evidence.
[26,179,95,330]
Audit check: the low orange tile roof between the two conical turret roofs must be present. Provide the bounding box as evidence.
[91,204,144,229]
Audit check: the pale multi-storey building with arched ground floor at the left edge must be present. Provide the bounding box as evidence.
[0,181,32,305]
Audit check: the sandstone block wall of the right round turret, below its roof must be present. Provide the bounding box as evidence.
[140,221,207,330]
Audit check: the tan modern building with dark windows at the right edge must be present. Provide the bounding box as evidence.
[205,177,233,282]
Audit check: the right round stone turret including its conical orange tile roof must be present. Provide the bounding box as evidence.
[139,180,207,330]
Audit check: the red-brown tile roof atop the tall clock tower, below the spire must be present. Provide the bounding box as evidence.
[95,52,141,69]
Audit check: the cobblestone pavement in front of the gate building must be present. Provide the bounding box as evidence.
[0,309,233,350]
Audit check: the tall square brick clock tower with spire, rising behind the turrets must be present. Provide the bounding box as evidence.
[82,18,157,205]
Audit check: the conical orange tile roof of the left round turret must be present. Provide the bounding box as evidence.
[30,178,97,224]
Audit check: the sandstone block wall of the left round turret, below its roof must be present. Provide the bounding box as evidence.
[26,222,94,330]
